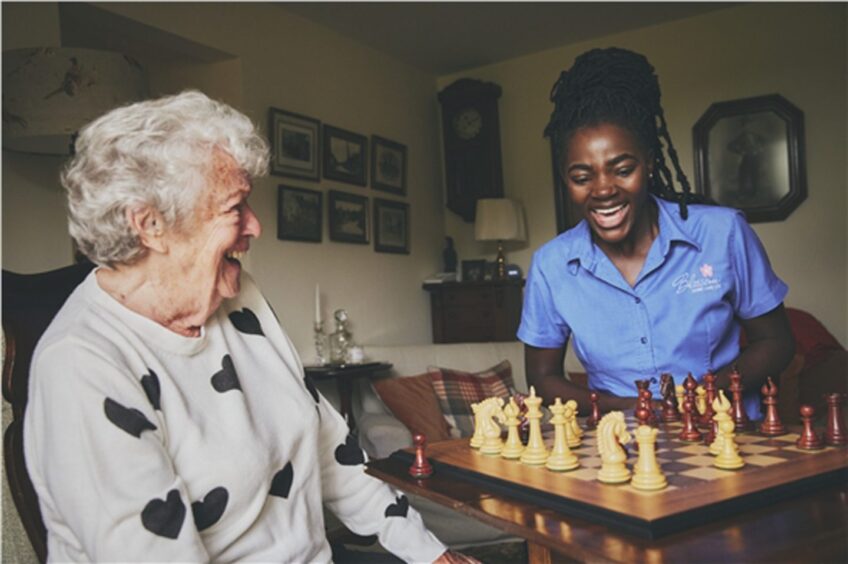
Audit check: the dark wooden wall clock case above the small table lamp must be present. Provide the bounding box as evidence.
[439,78,503,222]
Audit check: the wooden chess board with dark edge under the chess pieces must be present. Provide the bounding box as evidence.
[392,417,848,539]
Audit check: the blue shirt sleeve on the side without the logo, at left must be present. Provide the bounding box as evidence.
[518,252,571,349]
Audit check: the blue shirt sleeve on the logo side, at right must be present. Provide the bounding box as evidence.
[730,213,789,319]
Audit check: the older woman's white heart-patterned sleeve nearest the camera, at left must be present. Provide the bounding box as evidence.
[25,338,209,562]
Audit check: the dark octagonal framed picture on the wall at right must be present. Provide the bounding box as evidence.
[692,94,807,223]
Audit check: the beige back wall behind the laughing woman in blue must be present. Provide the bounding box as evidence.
[438,3,848,344]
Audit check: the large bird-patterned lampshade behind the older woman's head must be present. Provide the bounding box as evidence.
[3,47,147,155]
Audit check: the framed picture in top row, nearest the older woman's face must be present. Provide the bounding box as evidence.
[268,108,321,180]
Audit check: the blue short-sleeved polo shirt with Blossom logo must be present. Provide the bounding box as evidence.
[518,196,788,418]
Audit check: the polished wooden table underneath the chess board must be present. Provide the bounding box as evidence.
[367,452,848,563]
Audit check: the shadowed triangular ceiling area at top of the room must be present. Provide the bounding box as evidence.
[279,2,739,76]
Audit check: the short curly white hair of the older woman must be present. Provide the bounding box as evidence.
[61,90,269,266]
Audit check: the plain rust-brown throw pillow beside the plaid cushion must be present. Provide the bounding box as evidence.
[373,374,451,443]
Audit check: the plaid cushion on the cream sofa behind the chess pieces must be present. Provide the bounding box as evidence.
[429,360,515,437]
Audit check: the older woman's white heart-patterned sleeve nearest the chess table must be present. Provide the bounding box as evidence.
[318,390,447,562]
